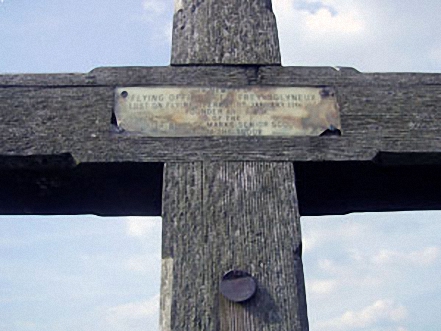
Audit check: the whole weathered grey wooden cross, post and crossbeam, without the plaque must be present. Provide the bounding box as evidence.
[0,0,441,331]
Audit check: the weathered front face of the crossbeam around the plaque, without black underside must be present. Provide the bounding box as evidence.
[0,66,441,163]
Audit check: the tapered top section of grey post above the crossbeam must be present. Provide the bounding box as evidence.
[171,0,281,65]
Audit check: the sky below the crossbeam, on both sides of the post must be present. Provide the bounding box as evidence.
[0,211,441,331]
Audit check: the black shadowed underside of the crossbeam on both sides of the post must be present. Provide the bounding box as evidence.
[0,154,441,216]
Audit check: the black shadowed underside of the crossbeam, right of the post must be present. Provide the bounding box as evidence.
[294,162,441,216]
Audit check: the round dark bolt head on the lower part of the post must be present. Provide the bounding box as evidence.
[220,270,257,302]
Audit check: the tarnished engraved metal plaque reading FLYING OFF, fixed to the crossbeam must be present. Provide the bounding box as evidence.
[115,87,341,137]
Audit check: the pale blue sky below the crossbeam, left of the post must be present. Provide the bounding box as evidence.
[0,216,162,331]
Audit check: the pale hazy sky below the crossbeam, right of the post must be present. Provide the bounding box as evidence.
[301,212,441,331]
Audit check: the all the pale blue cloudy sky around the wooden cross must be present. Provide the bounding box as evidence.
[0,0,441,331]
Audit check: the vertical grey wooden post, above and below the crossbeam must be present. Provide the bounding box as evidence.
[161,0,308,331]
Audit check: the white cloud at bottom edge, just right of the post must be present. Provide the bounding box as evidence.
[315,300,407,331]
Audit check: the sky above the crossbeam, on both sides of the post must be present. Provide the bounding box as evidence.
[0,0,441,72]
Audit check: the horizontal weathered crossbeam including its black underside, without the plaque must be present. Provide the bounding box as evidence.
[0,66,441,215]
